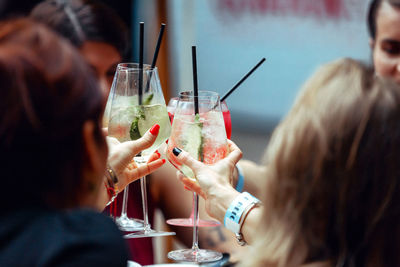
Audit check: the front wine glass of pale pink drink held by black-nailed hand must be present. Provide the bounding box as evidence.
[167,91,228,262]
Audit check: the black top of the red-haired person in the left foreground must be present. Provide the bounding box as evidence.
[0,210,128,267]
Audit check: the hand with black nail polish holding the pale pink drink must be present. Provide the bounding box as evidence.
[173,140,242,220]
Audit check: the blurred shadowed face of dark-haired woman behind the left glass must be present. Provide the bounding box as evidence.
[79,41,122,96]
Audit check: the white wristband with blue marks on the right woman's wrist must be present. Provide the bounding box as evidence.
[224,192,261,246]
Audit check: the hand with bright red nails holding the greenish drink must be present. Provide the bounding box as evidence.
[107,124,165,190]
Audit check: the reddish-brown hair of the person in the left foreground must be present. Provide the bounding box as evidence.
[0,19,105,209]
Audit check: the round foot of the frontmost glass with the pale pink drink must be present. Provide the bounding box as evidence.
[168,249,222,262]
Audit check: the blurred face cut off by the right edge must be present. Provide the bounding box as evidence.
[372,1,400,84]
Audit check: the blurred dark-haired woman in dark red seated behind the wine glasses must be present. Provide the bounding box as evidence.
[30,0,253,265]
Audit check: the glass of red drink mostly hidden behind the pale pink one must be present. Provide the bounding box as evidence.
[166,97,232,227]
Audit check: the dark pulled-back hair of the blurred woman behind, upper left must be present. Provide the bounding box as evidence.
[30,0,128,57]
